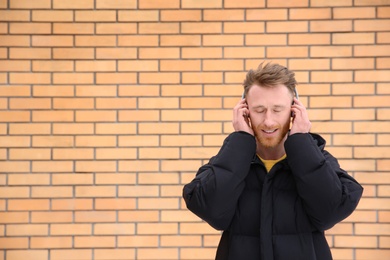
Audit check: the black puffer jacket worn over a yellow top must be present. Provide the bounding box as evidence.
[183,132,363,260]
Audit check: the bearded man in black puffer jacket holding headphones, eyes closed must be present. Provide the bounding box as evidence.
[183,64,363,260]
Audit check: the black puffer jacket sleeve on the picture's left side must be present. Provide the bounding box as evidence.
[183,132,256,230]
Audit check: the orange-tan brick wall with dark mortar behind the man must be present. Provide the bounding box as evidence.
[0,0,390,260]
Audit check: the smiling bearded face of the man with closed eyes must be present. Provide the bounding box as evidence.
[247,85,293,148]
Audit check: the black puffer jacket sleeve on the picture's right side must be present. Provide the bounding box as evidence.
[285,134,363,231]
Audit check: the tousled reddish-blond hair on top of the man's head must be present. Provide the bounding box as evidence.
[243,62,298,96]
